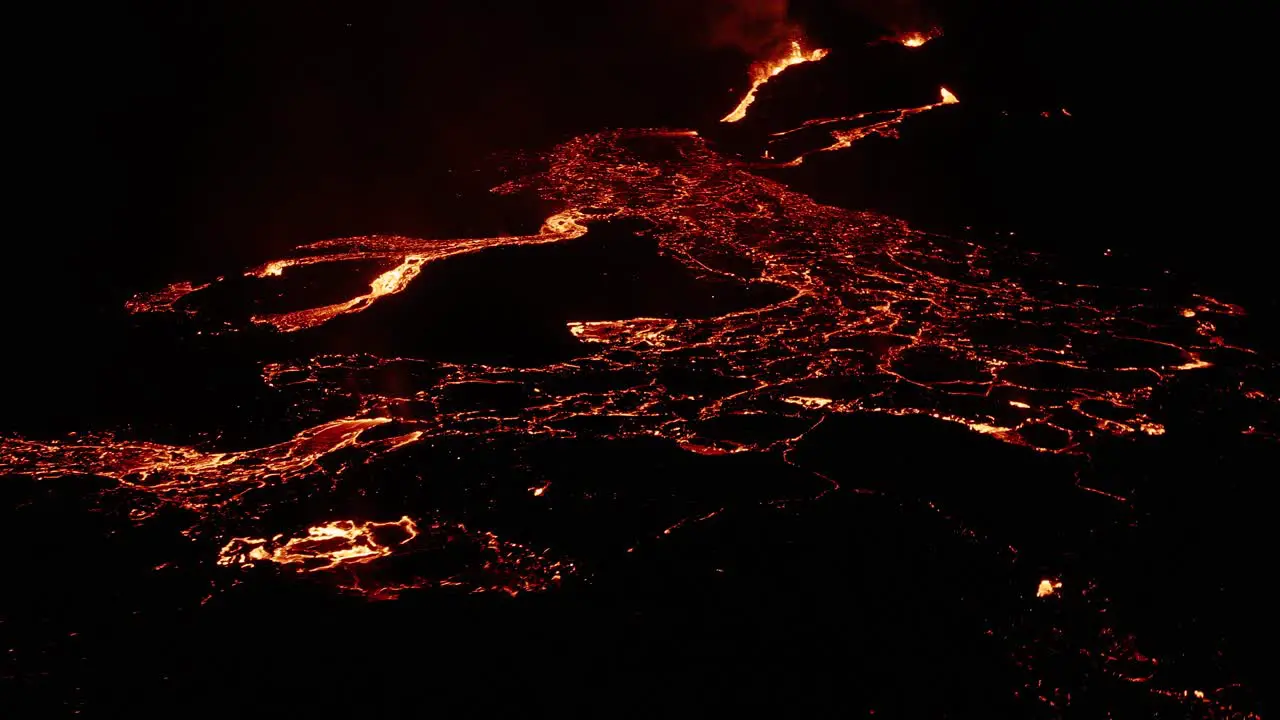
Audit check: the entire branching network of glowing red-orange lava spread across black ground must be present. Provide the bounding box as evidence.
[0,54,1276,716]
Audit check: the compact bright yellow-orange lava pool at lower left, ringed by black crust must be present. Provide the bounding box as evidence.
[218,515,417,573]
